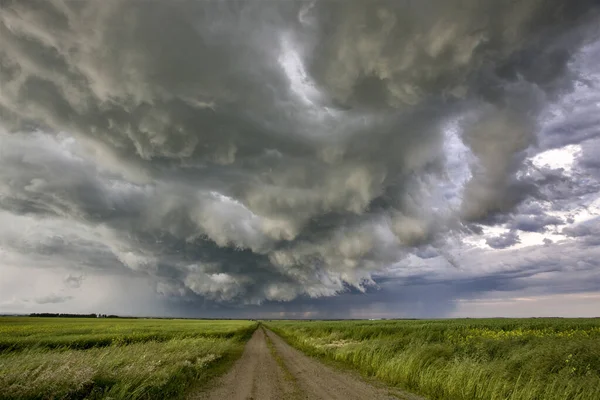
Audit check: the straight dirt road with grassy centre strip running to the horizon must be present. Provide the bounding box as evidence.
[191,329,420,400]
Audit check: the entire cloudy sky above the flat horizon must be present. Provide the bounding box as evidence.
[0,0,600,318]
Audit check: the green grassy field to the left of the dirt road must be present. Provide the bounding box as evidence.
[0,317,256,400]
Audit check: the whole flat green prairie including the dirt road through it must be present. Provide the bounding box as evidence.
[0,317,600,400]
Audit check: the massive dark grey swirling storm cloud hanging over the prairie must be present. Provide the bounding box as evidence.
[0,0,598,303]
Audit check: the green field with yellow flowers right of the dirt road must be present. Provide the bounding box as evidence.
[266,319,600,400]
